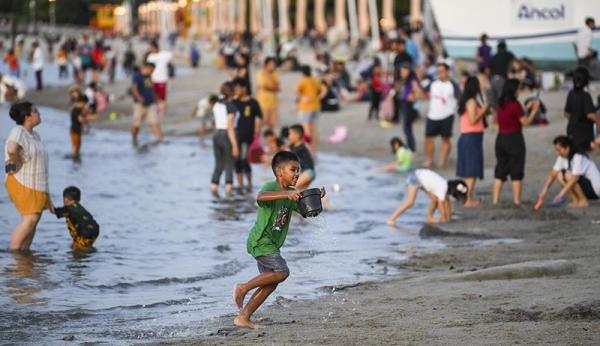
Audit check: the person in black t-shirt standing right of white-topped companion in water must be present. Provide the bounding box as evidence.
[233,78,262,192]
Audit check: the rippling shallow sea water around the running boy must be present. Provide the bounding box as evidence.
[0,107,442,344]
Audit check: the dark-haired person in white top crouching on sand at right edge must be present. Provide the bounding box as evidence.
[535,136,600,209]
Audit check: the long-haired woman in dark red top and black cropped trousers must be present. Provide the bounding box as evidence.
[492,79,540,206]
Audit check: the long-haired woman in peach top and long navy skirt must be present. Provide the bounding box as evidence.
[456,77,489,208]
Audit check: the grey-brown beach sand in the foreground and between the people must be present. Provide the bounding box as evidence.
[28,62,600,345]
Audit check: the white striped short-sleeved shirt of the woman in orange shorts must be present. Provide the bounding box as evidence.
[4,125,49,192]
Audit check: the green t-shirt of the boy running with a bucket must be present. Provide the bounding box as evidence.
[246,181,300,257]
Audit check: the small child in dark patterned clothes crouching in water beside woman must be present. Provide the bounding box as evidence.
[54,186,100,250]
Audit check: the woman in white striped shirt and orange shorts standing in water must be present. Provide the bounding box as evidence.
[4,102,54,251]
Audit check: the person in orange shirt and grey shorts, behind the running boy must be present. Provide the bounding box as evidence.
[296,65,327,154]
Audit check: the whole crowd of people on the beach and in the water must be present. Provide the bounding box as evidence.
[0,15,600,328]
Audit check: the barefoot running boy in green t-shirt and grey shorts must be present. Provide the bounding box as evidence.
[233,151,325,329]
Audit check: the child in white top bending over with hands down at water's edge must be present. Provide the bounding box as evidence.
[387,169,468,226]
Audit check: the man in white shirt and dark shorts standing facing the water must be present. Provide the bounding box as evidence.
[424,62,458,167]
